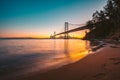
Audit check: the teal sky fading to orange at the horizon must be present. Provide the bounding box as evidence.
[0,0,106,37]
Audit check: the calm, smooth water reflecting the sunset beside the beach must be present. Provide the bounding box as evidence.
[0,39,89,77]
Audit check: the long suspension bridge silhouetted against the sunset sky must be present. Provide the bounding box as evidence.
[50,22,88,39]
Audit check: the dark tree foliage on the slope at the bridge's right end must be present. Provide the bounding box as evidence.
[86,0,120,38]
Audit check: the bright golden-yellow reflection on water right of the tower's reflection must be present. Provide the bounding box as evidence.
[66,41,89,63]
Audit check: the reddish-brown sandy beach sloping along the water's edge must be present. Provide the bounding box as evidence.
[9,45,120,80]
